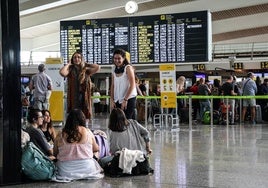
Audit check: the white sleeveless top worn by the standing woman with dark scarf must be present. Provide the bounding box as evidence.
[112,65,137,104]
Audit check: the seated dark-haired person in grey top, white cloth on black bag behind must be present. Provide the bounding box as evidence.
[100,108,152,176]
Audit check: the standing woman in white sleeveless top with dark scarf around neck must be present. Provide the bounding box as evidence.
[110,49,137,119]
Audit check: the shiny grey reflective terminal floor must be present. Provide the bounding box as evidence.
[3,114,268,188]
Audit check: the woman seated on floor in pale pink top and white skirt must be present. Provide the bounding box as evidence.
[54,109,104,181]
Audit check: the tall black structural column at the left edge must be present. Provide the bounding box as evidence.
[0,0,21,185]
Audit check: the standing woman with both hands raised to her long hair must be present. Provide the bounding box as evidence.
[60,52,100,119]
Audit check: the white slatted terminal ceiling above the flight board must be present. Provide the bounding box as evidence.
[19,0,268,51]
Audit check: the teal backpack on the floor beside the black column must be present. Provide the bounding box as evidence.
[21,142,56,180]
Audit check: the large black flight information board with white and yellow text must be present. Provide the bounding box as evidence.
[60,11,212,65]
